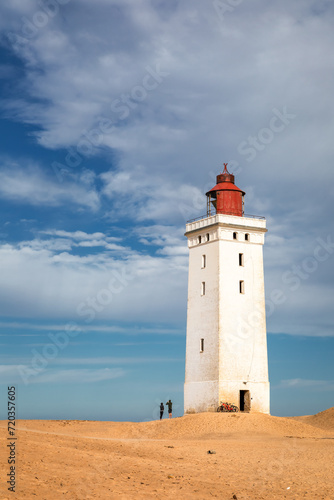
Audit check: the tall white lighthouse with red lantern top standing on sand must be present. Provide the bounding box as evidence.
[184,164,270,413]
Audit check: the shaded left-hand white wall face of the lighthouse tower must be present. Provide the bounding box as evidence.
[184,230,219,412]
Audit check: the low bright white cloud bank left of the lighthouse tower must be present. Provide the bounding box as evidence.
[0,231,187,324]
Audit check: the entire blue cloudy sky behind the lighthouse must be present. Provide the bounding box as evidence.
[0,0,334,420]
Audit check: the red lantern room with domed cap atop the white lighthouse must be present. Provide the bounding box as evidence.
[206,163,246,217]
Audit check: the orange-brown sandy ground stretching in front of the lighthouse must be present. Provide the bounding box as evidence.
[0,408,334,500]
